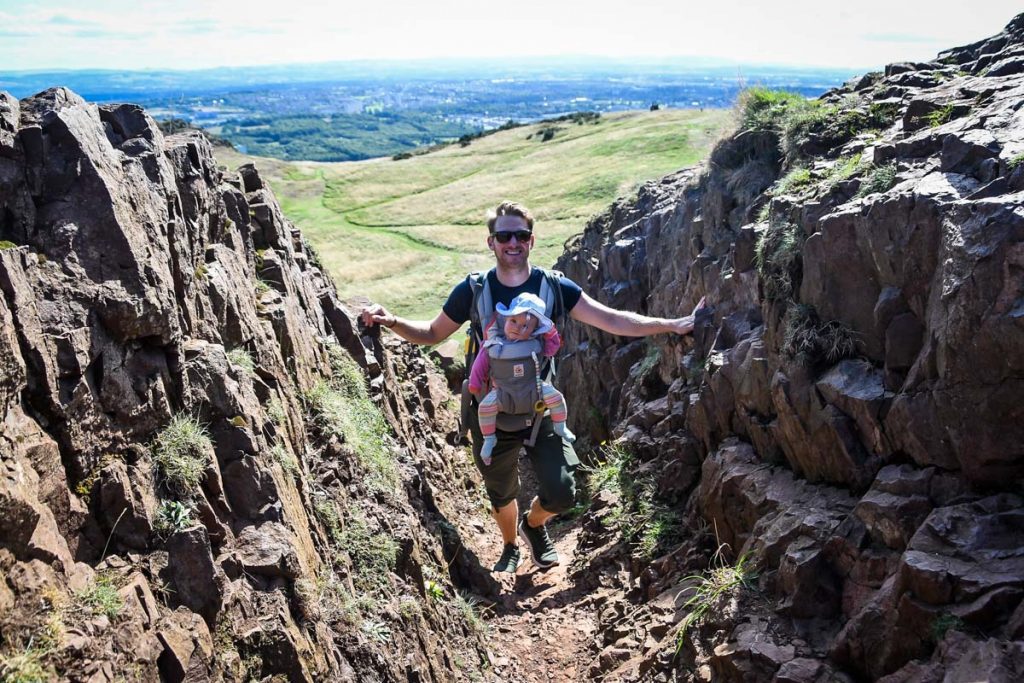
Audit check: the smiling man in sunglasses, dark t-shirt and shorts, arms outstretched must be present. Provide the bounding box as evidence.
[361,202,703,572]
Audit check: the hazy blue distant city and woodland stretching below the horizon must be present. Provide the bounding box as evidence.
[0,59,860,161]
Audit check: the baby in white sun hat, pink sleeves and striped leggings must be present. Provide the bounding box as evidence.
[469,294,574,465]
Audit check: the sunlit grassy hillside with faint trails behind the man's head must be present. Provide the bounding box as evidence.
[217,110,729,318]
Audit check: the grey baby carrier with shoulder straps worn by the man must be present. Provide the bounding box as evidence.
[462,269,564,445]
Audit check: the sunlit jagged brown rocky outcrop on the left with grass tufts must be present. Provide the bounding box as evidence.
[0,88,489,681]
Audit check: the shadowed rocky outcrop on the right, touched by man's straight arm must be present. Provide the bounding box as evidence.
[558,15,1024,681]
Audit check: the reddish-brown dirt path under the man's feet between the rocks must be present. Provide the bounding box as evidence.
[462,520,598,683]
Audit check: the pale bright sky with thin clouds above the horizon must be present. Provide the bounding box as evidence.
[0,0,1024,72]
